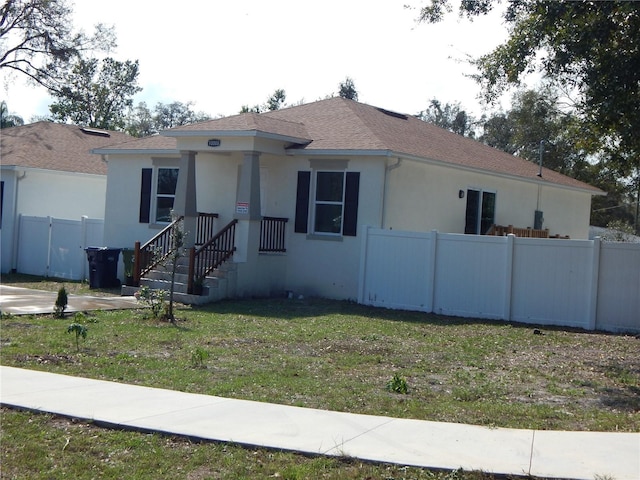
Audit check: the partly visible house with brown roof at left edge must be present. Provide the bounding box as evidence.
[0,122,131,273]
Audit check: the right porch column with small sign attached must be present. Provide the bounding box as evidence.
[234,151,262,263]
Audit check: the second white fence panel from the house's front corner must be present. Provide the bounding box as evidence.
[433,234,507,319]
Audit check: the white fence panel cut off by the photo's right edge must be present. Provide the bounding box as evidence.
[596,243,640,331]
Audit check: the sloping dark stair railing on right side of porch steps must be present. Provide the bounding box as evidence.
[187,219,238,293]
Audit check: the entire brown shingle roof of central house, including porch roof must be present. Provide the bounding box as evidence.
[97,97,603,194]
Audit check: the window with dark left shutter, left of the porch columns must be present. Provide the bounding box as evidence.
[139,167,179,223]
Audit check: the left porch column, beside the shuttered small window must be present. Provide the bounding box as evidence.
[173,151,198,248]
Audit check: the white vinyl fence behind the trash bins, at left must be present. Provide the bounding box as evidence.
[16,215,104,280]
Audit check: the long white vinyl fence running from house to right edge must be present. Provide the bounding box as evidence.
[358,228,640,332]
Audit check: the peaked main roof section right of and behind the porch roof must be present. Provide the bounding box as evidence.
[264,97,602,194]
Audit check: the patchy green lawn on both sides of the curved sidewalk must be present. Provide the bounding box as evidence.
[0,276,640,479]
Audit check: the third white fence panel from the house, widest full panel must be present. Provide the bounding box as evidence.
[511,238,593,328]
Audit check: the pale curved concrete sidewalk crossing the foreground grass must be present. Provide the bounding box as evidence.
[0,366,640,480]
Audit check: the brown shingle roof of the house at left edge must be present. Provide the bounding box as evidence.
[0,122,131,175]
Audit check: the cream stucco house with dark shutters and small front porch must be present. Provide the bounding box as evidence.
[94,97,603,299]
